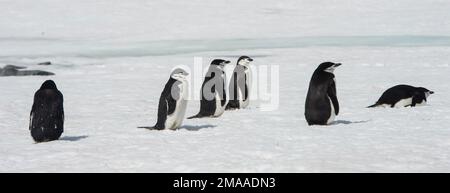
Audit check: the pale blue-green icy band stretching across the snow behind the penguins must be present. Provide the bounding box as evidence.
[0,35,450,58]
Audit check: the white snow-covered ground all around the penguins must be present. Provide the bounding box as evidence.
[0,0,450,172]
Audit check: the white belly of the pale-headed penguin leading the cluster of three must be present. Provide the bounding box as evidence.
[165,82,188,130]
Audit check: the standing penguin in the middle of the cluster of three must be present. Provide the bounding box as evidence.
[188,59,230,119]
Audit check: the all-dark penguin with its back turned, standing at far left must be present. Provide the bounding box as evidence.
[30,80,64,142]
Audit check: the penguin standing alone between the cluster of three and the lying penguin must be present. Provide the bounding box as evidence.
[305,62,341,125]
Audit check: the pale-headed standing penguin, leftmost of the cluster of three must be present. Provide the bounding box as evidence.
[139,68,189,130]
